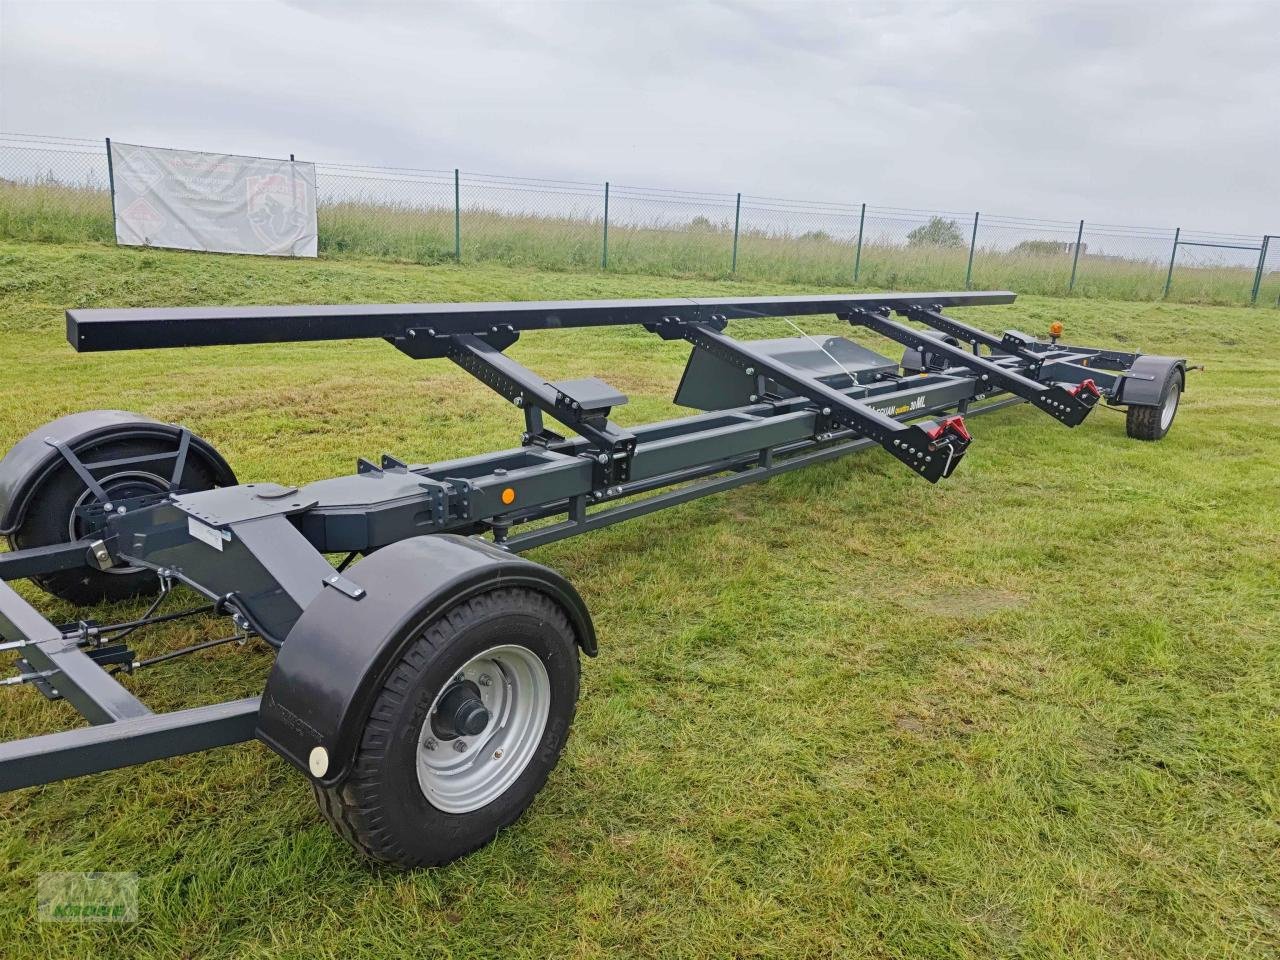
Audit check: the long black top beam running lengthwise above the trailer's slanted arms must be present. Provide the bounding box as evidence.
[67,291,1014,352]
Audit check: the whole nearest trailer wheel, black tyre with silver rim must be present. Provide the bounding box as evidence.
[312,589,579,867]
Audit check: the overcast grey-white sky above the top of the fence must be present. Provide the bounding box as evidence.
[0,0,1280,233]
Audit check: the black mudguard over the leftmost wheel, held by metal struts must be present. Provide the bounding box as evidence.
[0,410,236,535]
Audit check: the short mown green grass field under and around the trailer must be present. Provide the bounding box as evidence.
[0,242,1280,960]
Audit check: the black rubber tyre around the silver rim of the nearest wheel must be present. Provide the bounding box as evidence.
[311,589,579,868]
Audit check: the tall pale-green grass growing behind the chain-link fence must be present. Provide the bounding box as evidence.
[0,182,1280,305]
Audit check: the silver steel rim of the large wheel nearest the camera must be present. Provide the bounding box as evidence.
[417,644,552,813]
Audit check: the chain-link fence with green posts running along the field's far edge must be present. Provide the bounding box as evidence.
[0,134,1280,306]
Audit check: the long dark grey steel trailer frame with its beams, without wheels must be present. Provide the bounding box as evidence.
[0,291,1185,808]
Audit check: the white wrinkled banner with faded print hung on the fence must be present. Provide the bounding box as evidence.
[110,141,316,257]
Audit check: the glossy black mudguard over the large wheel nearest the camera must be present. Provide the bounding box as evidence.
[256,534,595,786]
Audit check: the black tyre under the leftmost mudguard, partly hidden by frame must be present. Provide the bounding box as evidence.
[9,436,215,605]
